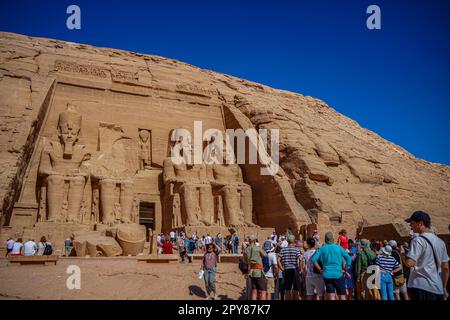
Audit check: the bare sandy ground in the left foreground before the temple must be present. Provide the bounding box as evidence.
[0,257,245,300]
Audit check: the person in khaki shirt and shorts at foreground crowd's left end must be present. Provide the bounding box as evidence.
[244,235,267,300]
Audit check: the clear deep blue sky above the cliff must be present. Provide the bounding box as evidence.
[0,0,450,165]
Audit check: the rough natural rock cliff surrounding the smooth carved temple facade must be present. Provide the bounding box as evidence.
[0,33,450,233]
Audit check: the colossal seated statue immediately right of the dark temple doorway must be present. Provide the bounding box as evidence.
[163,129,213,226]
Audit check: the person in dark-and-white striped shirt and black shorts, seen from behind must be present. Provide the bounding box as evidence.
[278,234,302,300]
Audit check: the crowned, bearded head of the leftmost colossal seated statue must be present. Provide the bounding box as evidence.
[58,103,81,157]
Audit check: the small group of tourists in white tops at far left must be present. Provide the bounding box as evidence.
[6,237,53,257]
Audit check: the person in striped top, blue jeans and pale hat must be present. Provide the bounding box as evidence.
[375,245,401,300]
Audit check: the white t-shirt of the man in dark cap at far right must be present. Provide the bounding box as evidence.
[407,232,448,294]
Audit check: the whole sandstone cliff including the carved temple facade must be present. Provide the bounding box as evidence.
[0,33,450,242]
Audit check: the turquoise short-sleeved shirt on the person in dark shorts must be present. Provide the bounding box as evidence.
[311,243,352,279]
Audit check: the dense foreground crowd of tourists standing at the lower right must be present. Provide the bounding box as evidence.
[239,211,449,300]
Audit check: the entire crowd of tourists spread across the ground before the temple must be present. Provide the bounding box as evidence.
[6,211,450,300]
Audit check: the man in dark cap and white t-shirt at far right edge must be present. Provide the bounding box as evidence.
[405,211,449,300]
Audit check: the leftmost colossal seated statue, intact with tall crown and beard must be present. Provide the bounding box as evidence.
[38,104,90,222]
